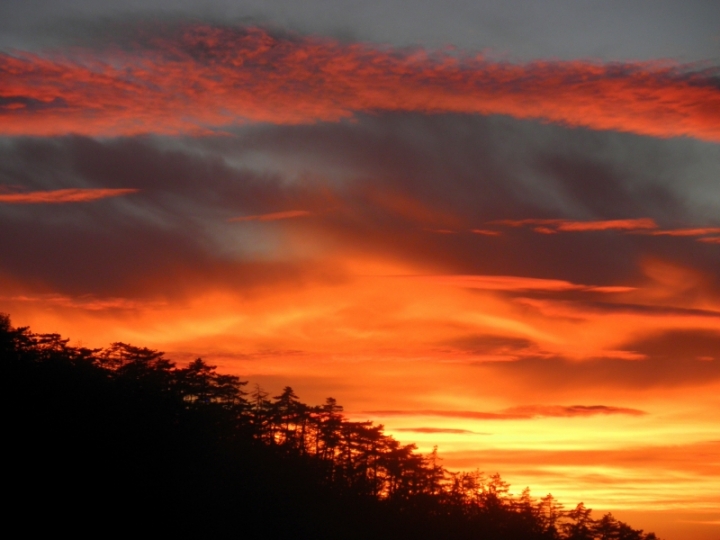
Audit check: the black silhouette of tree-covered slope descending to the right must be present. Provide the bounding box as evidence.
[0,314,656,540]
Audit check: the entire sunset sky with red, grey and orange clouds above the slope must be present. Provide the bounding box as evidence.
[0,0,720,540]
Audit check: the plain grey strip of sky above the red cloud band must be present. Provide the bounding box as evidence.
[0,0,720,61]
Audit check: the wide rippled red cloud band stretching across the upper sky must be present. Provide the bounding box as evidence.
[0,25,720,141]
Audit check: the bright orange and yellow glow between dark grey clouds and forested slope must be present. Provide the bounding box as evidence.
[5,261,720,540]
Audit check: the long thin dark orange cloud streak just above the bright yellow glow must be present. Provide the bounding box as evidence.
[365,405,647,420]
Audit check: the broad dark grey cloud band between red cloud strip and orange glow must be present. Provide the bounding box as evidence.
[0,115,720,302]
